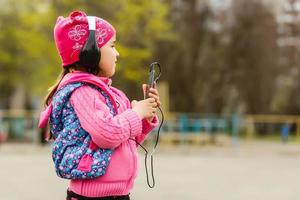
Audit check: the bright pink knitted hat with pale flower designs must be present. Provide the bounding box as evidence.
[54,11,116,66]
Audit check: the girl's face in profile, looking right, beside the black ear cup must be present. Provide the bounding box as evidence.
[99,34,119,78]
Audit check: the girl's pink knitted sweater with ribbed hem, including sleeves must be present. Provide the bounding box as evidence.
[42,71,158,197]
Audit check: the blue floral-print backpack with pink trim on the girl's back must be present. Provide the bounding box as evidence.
[50,82,116,179]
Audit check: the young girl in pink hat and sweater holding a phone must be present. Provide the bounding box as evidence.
[39,11,160,200]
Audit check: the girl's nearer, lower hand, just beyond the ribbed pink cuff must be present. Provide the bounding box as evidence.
[131,98,157,119]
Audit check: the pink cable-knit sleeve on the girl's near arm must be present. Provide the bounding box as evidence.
[70,86,142,149]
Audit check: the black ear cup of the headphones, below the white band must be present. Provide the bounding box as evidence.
[79,30,101,69]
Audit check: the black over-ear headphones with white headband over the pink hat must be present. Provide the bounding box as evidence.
[78,16,101,73]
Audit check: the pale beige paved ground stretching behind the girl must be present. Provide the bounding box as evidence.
[0,142,300,200]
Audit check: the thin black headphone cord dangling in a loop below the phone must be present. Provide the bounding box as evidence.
[131,107,165,188]
